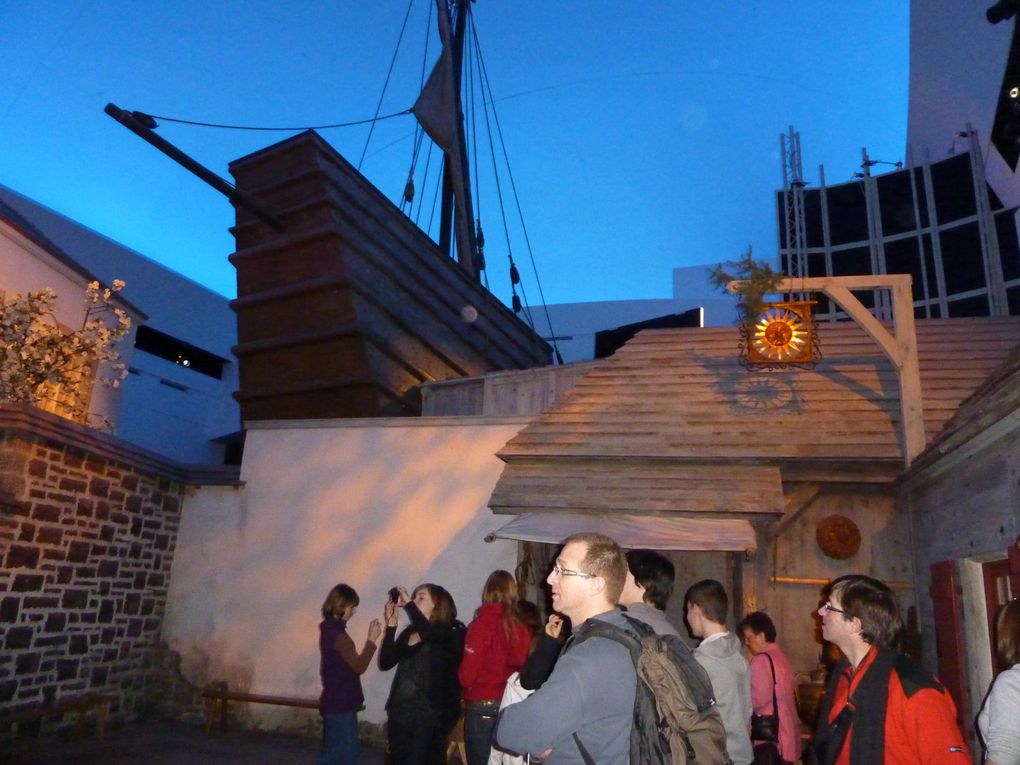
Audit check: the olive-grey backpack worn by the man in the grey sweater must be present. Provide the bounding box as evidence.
[574,616,731,765]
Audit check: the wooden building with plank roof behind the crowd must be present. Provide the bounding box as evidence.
[424,318,1020,722]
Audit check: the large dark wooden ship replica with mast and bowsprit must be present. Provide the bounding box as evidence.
[106,0,551,421]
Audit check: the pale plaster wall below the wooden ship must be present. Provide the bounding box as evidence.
[164,417,526,727]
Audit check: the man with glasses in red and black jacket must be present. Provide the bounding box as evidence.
[806,574,970,765]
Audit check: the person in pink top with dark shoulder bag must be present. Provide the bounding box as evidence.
[737,611,801,763]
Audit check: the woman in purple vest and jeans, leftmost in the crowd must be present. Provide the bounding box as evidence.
[319,584,383,765]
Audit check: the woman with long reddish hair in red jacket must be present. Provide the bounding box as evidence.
[458,570,531,765]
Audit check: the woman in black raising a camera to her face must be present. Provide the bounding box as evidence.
[379,583,464,765]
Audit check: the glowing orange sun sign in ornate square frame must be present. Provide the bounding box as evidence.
[741,300,821,368]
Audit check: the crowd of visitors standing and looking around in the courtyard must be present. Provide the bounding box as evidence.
[319,533,1020,765]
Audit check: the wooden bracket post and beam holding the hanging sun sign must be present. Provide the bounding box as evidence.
[726,273,925,465]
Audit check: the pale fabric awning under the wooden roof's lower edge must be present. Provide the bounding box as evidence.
[486,513,758,551]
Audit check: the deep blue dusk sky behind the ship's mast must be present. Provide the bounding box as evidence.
[0,0,909,312]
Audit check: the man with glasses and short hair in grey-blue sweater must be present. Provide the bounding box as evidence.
[496,533,638,765]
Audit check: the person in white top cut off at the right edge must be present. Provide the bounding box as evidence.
[977,600,1020,765]
